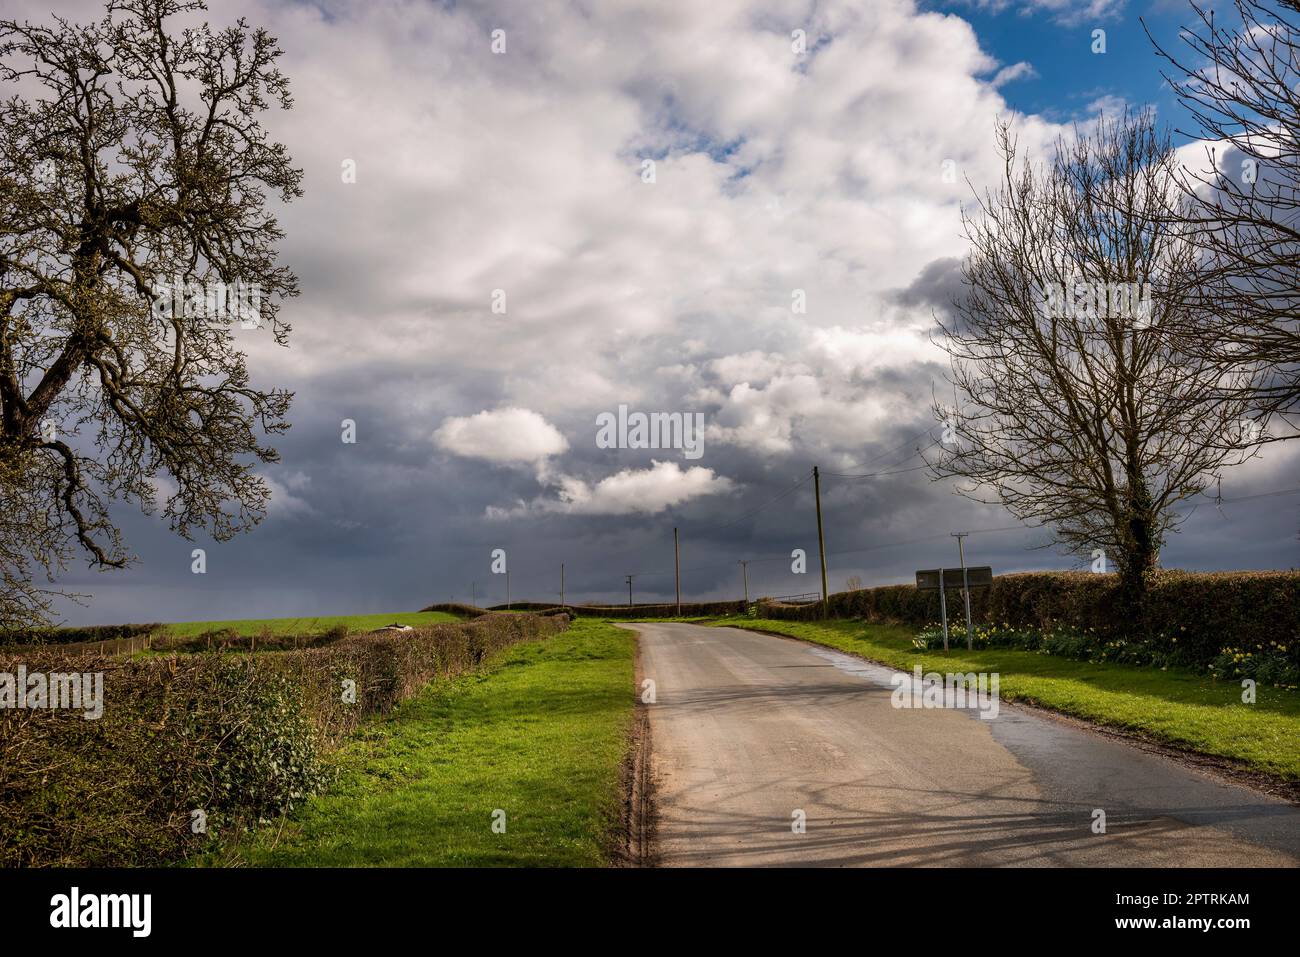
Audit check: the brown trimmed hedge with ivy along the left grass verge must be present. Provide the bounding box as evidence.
[0,615,568,867]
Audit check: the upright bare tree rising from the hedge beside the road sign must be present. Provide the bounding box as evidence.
[932,114,1251,603]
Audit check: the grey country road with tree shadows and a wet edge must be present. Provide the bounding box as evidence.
[624,623,1300,867]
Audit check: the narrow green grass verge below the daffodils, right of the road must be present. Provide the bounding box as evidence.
[715,618,1300,780]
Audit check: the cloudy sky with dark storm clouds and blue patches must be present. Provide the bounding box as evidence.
[15,0,1300,624]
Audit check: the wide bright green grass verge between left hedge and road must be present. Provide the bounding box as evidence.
[235,619,634,867]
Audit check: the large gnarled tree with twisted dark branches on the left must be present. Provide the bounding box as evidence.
[0,0,302,627]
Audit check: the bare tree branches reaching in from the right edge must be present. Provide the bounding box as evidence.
[1148,0,1300,442]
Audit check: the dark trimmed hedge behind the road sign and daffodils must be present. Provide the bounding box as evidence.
[759,571,1300,668]
